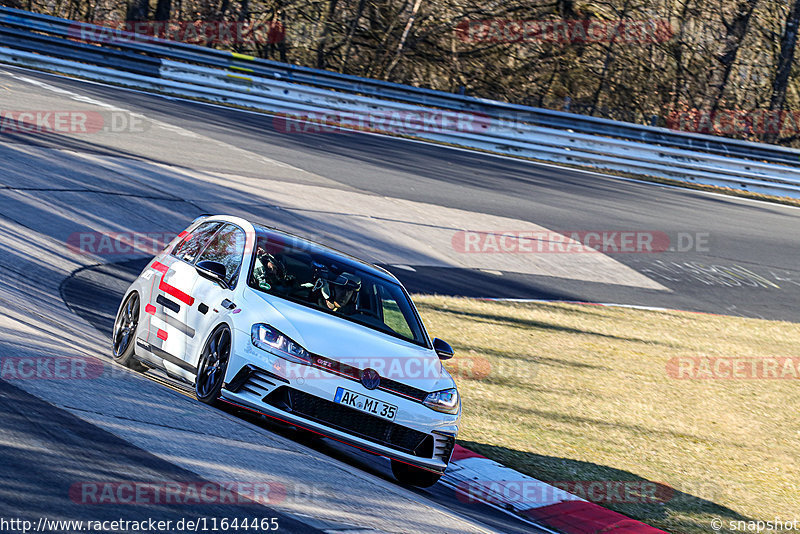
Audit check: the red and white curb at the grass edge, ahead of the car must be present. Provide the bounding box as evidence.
[443,445,667,534]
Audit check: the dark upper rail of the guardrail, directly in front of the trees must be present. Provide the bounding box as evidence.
[0,7,800,164]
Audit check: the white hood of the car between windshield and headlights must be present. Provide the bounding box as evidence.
[241,291,454,391]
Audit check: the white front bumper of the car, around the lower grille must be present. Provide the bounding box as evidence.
[221,331,461,473]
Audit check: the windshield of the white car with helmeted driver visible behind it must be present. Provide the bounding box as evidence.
[248,235,426,346]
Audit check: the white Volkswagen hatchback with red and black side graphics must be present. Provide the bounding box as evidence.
[112,216,461,487]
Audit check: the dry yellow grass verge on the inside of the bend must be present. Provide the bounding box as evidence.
[415,296,800,534]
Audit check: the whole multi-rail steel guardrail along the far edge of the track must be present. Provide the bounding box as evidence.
[0,7,800,198]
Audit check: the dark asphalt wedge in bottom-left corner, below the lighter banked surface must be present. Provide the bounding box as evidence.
[0,381,321,534]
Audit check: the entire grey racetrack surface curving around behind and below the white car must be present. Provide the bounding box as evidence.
[0,63,800,532]
